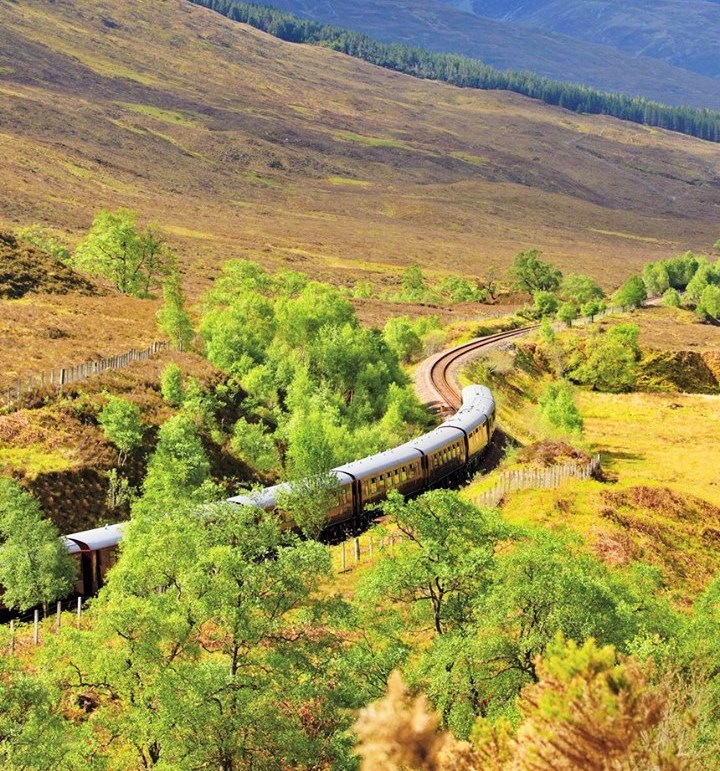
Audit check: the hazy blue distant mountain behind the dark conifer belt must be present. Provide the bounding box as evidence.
[267,0,720,109]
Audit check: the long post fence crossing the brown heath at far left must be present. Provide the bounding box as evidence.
[2,340,171,410]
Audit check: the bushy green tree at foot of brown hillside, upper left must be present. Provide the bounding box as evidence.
[72,209,172,296]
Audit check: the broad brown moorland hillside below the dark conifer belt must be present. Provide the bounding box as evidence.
[0,0,720,287]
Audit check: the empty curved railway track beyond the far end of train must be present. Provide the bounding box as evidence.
[418,324,537,413]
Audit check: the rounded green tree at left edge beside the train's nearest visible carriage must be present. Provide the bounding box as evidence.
[0,479,75,612]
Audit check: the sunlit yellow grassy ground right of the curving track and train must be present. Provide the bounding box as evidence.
[464,309,720,604]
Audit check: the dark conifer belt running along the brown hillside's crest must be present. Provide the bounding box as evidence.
[189,0,720,142]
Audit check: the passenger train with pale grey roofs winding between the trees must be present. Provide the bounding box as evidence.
[63,385,496,596]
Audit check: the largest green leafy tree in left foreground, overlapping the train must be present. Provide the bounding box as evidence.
[64,504,359,769]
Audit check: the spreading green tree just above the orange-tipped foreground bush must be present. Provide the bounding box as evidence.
[434,532,677,735]
